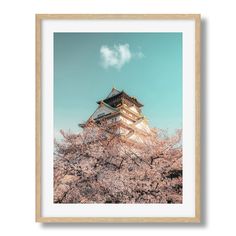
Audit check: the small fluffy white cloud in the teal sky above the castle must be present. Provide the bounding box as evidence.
[100,44,144,70]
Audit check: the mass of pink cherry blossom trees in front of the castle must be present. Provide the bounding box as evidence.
[54,120,182,203]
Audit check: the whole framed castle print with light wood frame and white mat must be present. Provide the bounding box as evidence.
[36,14,201,223]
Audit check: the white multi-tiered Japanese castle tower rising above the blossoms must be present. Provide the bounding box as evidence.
[80,88,151,142]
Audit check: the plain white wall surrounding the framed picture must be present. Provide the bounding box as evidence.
[0,0,236,236]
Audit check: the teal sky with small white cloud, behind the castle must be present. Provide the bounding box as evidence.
[54,33,182,136]
